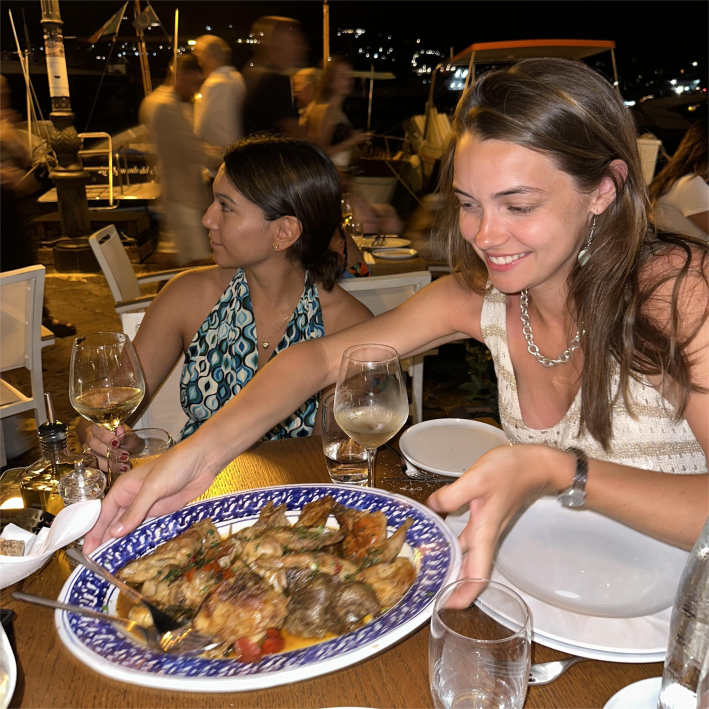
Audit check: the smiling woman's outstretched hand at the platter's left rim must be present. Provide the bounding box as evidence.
[84,441,219,554]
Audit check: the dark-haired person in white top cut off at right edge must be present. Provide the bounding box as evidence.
[650,118,709,241]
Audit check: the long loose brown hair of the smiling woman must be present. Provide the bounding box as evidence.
[441,59,707,450]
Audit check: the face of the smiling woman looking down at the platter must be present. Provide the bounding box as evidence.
[453,134,594,293]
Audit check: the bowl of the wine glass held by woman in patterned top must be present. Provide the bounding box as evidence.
[69,332,145,478]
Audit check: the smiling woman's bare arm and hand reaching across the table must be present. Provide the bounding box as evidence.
[85,278,482,551]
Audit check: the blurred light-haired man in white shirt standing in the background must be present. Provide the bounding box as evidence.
[192,34,246,150]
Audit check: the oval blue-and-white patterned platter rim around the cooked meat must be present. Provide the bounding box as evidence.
[55,485,461,692]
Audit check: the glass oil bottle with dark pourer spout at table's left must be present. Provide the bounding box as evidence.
[20,395,97,515]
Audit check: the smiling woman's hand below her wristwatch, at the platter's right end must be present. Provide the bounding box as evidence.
[427,445,576,603]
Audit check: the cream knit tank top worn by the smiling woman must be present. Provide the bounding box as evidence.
[481,288,707,474]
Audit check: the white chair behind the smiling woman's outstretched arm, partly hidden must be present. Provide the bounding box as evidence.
[338,271,437,423]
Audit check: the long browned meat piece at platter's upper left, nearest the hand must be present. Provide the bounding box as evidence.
[117,519,221,583]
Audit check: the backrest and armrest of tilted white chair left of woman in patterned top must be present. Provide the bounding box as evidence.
[89,224,187,324]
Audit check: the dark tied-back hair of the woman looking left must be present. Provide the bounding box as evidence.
[224,134,342,291]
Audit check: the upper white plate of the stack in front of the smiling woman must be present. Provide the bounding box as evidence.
[496,497,688,618]
